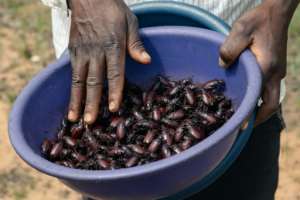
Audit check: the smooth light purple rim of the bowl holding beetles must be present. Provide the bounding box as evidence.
[9,26,261,181]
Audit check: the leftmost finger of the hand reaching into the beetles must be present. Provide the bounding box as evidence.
[68,50,88,122]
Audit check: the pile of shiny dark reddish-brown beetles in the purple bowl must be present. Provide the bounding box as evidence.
[41,76,234,170]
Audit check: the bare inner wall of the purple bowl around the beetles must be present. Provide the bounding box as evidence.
[13,27,258,173]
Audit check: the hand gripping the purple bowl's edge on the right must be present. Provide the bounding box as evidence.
[220,2,289,125]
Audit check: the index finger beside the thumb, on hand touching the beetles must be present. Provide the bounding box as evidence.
[106,42,126,112]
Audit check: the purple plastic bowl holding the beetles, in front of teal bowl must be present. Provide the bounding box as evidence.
[9,27,261,200]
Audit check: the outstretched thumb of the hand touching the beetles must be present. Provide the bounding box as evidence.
[127,15,151,64]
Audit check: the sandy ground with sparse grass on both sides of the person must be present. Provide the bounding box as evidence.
[0,0,300,200]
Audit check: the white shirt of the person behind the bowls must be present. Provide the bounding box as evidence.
[41,0,286,102]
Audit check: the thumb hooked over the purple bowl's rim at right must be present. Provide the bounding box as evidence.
[219,22,251,68]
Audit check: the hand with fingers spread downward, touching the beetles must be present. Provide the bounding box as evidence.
[68,0,151,124]
